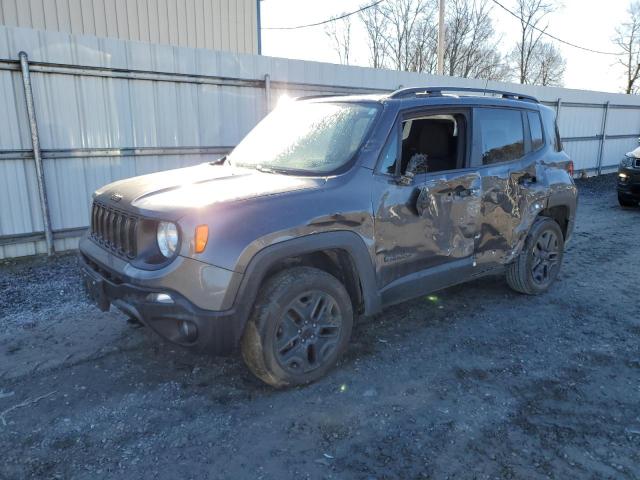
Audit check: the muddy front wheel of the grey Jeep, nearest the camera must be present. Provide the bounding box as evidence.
[241,267,353,388]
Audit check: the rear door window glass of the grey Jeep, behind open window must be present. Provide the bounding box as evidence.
[476,108,524,165]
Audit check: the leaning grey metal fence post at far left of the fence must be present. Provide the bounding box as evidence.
[18,52,54,256]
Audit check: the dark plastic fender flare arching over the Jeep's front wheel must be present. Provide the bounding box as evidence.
[229,230,382,340]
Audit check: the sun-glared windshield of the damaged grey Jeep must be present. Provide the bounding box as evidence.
[229,102,379,174]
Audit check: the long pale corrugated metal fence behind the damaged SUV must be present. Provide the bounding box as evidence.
[0,27,640,258]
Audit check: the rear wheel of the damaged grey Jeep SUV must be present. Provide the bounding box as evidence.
[507,217,564,295]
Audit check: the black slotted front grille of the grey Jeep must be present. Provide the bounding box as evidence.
[91,202,138,258]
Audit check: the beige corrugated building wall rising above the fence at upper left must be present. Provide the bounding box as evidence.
[0,0,258,54]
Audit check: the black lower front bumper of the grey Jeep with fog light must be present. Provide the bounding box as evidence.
[79,249,244,355]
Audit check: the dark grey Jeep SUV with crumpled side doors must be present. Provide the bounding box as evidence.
[80,87,577,387]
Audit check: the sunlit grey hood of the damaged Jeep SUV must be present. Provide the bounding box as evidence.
[96,163,324,217]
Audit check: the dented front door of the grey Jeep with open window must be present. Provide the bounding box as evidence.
[372,109,481,304]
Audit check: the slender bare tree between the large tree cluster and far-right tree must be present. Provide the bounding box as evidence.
[513,0,555,83]
